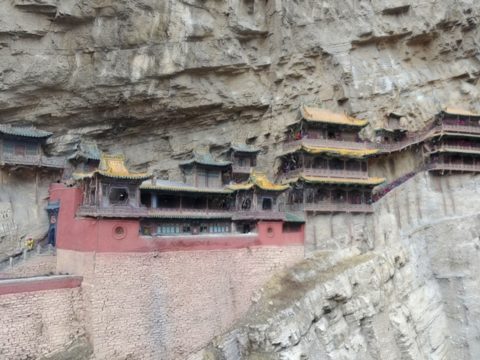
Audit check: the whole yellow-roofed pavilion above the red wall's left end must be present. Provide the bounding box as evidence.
[73,154,153,218]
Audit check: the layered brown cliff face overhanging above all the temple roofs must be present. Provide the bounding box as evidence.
[0,0,480,179]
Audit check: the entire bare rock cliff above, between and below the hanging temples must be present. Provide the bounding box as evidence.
[0,0,480,360]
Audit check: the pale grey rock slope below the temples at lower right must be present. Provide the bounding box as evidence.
[205,174,480,360]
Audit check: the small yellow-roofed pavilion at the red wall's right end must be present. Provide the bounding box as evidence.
[228,169,290,232]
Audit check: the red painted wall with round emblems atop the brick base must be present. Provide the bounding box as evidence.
[50,184,305,253]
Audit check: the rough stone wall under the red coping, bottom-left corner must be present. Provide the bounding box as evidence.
[0,280,85,360]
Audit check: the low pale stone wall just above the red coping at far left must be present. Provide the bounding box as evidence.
[0,254,57,279]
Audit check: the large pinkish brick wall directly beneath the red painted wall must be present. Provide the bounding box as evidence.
[57,246,304,360]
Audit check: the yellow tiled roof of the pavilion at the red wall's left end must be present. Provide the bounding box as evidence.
[73,153,152,180]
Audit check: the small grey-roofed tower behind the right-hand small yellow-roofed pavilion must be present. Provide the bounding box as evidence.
[226,140,261,183]
